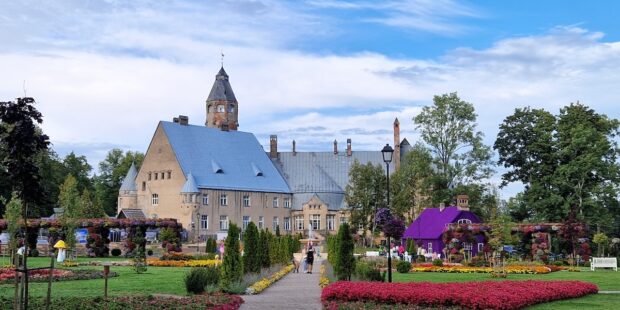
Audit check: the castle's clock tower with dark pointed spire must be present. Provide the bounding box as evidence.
[205,66,239,131]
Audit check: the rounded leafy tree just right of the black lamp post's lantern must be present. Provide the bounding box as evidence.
[390,144,434,222]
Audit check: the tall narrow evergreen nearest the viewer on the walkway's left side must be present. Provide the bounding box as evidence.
[220,223,243,290]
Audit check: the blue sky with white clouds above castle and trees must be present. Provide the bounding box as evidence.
[0,0,620,198]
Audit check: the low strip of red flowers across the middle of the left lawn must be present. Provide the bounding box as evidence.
[0,268,118,284]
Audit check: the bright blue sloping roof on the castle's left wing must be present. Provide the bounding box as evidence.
[160,121,291,193]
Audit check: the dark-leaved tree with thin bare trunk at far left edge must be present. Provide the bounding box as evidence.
[0,97,49,309]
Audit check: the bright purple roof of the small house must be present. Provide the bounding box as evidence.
[403,206,480,239]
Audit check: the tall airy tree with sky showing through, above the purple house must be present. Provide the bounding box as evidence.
[413,93,493,205]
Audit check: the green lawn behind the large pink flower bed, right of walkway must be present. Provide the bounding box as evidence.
[392,268,620,310]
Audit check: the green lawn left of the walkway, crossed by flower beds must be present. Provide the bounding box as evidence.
[0,258,190,298]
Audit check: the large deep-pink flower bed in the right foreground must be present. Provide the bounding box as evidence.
[321,280,598,309]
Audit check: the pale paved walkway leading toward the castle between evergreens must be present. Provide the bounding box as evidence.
[241,258,323,310]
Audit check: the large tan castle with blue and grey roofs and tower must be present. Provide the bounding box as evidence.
[118,67,410,239]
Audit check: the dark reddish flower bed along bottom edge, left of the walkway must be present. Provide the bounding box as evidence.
[0,294,243,310]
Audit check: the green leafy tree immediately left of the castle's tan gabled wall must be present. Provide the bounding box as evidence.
[95,149,144,215]
